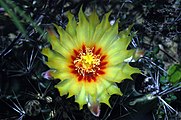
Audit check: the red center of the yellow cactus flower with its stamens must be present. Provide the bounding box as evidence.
[69,45,108,82]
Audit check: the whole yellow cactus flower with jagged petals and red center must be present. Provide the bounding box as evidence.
[42,9,140,109]
